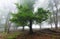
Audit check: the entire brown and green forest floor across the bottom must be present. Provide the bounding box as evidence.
[0,29,60,39]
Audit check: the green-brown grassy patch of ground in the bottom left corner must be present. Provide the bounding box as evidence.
[0,32,21,39]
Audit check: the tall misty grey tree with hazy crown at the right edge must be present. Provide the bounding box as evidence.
[48,0,60,29]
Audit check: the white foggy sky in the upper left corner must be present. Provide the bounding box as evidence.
[0,0,17,23]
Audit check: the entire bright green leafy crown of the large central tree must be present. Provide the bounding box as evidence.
[10,4,49,26]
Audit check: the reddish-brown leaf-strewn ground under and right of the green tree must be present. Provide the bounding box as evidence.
[16,29,60,39]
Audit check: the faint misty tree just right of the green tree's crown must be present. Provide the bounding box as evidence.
[48,0,55,28]
